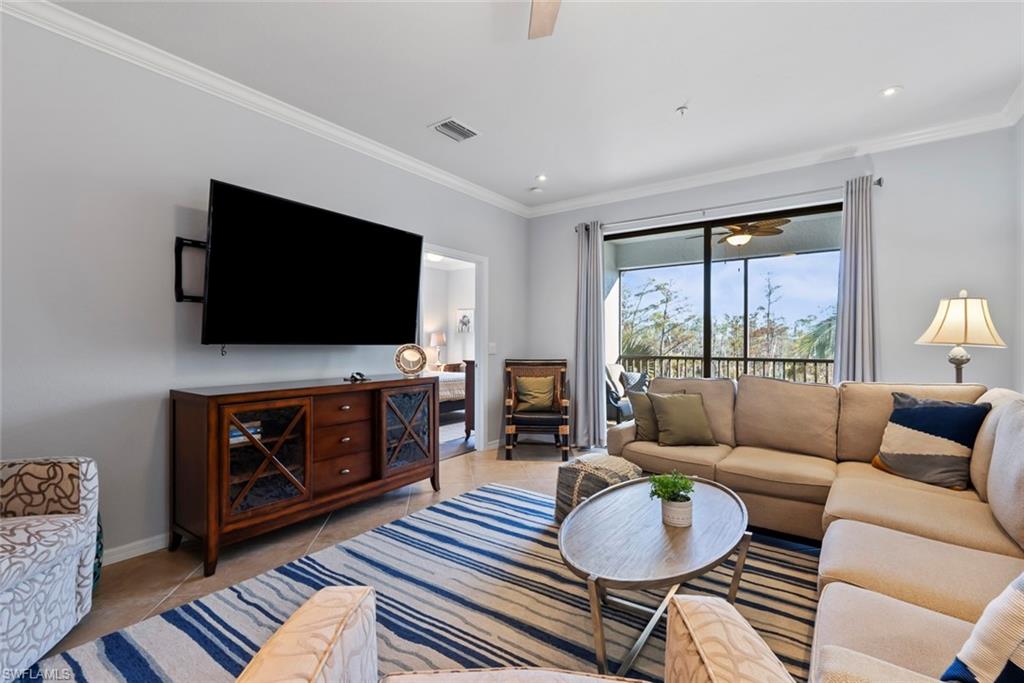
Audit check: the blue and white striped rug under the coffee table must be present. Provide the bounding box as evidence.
[27,484,817,683]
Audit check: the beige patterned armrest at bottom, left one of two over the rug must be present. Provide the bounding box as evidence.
[238,586,377,683]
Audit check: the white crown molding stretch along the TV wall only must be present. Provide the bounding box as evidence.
[6,0,529,217]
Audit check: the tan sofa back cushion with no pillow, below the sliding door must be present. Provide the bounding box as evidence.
[735,375,839,460]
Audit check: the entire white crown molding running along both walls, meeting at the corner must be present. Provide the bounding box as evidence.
[6,0,1024,223]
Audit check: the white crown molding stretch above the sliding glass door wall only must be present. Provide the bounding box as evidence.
[528,102,1024,218]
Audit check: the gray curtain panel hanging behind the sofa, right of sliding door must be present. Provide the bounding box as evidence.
[836,175,878,382]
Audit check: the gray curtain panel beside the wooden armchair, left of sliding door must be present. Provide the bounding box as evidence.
[569,221,607,449]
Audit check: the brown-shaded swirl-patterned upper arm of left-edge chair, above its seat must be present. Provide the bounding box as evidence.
[0,458,99,526]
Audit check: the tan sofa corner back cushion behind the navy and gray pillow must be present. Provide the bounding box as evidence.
[838,382,985,463]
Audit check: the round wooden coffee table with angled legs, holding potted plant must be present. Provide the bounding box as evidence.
[558,477,751,676]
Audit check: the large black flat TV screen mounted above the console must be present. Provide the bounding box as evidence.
[203,180,423,345]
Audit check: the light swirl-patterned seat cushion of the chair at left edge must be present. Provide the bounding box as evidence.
[0,515,90,591]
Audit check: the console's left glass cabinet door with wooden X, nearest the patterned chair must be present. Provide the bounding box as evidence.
[220,398,312,525]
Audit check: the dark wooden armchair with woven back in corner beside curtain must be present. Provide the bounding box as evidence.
[505,358,569,461]
